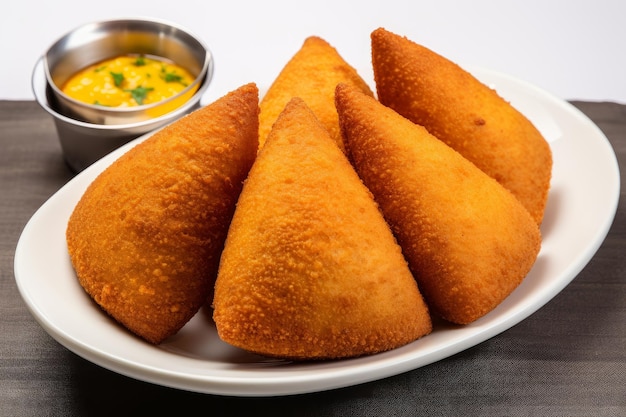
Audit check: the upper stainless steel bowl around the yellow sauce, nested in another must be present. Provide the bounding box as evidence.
[43,19,213,125]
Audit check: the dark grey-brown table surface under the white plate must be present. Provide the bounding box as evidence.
[0,101,626,416]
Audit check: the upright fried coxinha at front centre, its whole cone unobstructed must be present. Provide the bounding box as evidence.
[213,98,431,359]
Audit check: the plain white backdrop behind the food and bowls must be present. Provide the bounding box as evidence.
[0,0,626,103]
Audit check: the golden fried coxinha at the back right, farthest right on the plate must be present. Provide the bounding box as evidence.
[371,28,552,224]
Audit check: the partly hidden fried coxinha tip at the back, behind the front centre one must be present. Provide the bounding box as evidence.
[259,36,373,150]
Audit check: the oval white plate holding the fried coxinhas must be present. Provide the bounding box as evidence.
[15,70,620,396]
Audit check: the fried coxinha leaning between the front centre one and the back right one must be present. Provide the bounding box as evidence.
[337,85,541,324]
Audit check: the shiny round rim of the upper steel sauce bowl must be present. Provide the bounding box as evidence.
[41,17,213,115]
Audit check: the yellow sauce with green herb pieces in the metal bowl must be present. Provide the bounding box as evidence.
[62,55,198,114]
